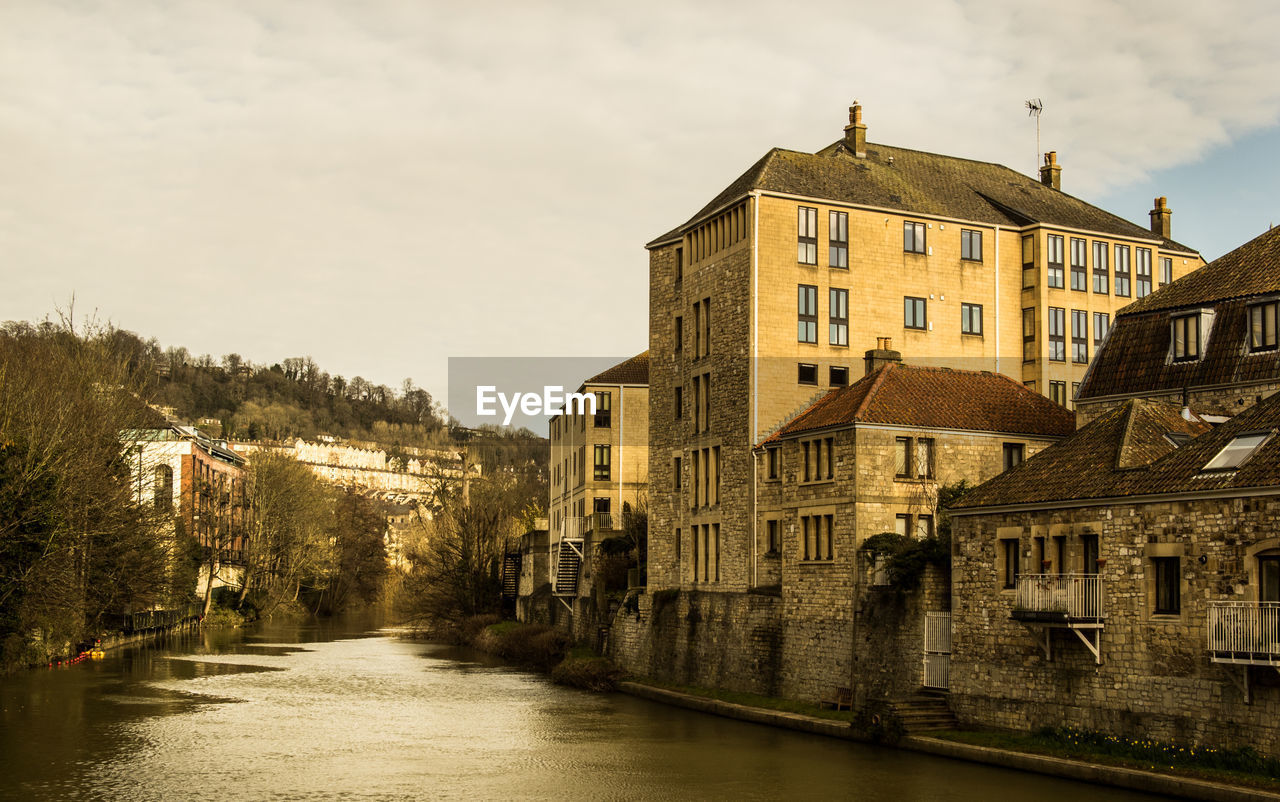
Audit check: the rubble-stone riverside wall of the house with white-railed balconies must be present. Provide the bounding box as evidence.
[951,498,1280,753]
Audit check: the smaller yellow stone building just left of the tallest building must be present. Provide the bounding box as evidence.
[545,352,649,629]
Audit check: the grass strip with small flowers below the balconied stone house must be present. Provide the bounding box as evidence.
[929,729,1280,790]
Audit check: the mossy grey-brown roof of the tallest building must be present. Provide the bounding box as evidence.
[649,139,1196,253]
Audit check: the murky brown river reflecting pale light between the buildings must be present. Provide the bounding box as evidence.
[0,620,1152,802]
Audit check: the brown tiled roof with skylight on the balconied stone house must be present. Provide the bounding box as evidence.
[955,394,1280,509]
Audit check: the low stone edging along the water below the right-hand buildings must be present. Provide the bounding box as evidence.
[618,680,1280,802]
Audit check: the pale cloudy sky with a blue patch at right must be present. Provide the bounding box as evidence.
[0,0,1280,406]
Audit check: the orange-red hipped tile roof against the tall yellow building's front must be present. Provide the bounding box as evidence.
[765,363,1075,443]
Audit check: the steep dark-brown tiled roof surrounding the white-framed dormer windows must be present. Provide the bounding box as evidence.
[1078,223,1280,401]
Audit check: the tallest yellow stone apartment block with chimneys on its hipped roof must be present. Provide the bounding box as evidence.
[646,105,1202,603]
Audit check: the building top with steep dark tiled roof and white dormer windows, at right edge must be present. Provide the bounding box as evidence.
[1076,223,1280,423]
